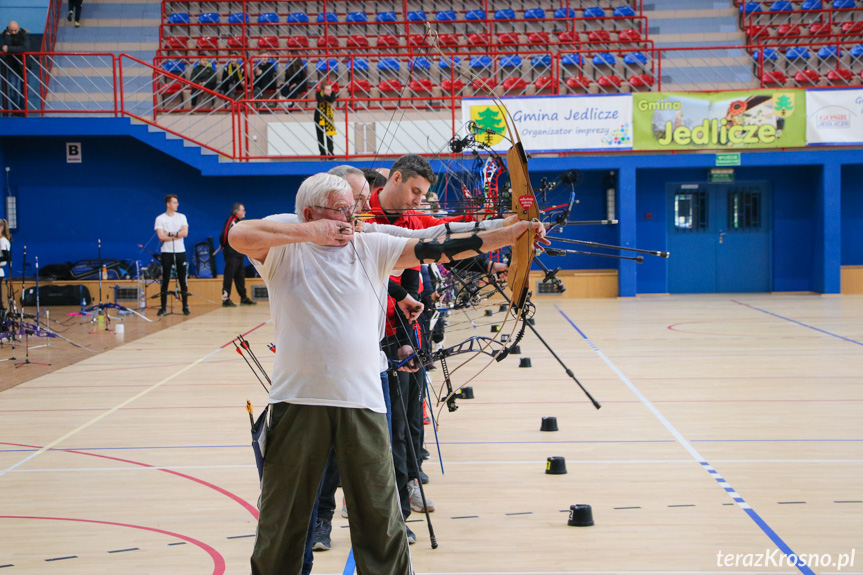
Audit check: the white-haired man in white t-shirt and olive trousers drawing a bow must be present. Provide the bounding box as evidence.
[230,174,541,575]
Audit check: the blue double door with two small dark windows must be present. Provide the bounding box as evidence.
[668,182,772,293]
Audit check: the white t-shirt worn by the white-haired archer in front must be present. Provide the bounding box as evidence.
[250,214,408,413]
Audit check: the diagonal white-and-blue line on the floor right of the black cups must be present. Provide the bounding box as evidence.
[555,306,815,575]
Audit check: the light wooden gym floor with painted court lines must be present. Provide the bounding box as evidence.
[0,294,863,575]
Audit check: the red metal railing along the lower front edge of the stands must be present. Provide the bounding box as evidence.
[0,41,863,161]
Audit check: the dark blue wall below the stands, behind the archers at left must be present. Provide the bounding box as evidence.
[0,137,302,274]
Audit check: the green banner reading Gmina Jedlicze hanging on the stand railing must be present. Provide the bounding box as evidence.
[633,90,806,150]
